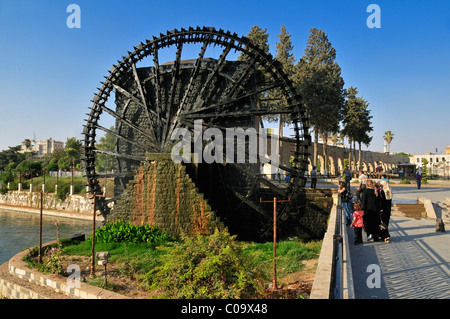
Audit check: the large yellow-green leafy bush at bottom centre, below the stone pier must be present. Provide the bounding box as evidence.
[142,230,264,299]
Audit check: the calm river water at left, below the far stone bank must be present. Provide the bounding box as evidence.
[0,208,101,265]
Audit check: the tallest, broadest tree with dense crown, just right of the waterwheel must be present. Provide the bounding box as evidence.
[296,28,345,172]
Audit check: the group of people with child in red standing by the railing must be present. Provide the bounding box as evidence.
[338,171,392,245]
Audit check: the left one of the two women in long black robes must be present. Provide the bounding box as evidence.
[361,180,381,241]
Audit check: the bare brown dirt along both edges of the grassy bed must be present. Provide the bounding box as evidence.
[54,256,318,299]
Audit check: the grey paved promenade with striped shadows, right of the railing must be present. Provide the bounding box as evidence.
[348,185,450,299]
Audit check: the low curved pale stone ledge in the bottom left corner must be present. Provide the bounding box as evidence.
[0,241,132,299]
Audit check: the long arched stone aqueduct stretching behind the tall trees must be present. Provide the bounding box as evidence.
[280,141,409,176]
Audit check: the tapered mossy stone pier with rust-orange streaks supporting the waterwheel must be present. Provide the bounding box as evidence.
[107,154,222,236]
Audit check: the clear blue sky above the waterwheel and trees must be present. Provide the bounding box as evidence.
[0,0,450,154]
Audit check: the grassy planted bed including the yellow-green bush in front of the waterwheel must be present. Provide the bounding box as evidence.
[24,233,322,298]
